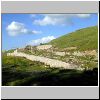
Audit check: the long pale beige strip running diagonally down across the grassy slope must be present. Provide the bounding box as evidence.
[7,50,77,69]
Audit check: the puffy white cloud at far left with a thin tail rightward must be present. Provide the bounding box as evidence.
[6,21,41,36]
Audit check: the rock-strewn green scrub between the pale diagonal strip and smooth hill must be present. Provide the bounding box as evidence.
[22,46,98,69]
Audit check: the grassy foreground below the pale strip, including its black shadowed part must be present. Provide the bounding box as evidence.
[2,54,98,86]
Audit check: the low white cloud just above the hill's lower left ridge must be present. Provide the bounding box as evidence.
[28,36,55,45]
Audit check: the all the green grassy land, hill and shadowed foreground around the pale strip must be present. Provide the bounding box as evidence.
[2,26,98,86]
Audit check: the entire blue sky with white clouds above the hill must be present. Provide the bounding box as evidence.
[2,14,98,50]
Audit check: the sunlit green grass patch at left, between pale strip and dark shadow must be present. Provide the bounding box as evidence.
[2,54,48,72]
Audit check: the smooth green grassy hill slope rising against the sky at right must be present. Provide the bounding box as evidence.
[49,26,98,50]
